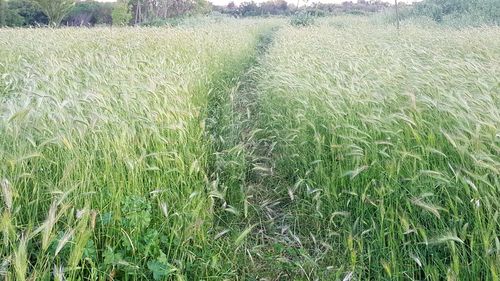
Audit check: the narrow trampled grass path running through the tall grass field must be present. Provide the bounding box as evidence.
[204,27,308,280]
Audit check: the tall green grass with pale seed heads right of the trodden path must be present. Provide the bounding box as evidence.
[255,21,500,280]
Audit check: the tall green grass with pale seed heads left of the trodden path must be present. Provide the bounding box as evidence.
[0,21,274,280]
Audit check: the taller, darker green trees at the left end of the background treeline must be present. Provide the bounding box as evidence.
[0,0,211,27]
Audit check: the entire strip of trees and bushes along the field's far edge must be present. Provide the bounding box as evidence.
[0,0,500,27]
